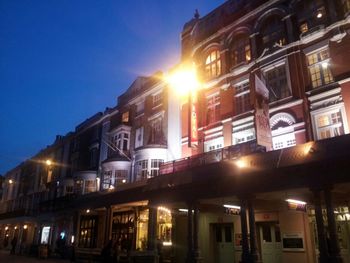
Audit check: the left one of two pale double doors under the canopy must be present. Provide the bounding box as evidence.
[213,224,235,263]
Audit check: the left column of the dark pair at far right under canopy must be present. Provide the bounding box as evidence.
[313,189,329,263]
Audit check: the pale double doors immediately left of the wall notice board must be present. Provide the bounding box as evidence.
[258,222,282,263]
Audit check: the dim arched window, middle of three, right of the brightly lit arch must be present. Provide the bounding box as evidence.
[231,34,252,66]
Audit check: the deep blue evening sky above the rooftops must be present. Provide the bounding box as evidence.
[0,0,224,174]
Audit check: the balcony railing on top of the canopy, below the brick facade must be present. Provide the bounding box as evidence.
[159,141,266,175]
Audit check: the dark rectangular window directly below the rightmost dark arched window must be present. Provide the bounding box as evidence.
[264,64,291,102]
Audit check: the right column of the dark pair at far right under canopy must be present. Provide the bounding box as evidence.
[324,188,343,263]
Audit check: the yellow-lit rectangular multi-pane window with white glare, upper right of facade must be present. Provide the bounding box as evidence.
[307,49,333,88]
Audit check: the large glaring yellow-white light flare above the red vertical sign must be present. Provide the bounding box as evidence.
[166,66,199,96]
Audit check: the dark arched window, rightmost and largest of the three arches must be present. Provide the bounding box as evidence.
[260,15,287,49]
